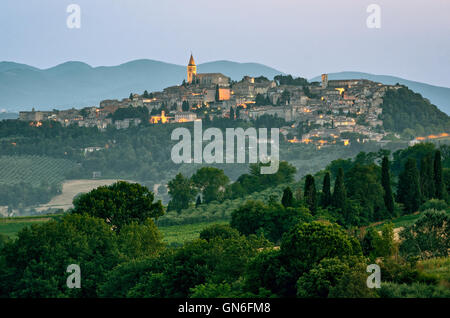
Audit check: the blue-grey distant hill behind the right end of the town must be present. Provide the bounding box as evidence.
[311,72,450,115]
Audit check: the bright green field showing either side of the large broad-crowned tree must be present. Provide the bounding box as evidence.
[0,215,227,245]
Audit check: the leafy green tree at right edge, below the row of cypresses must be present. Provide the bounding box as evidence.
[400,210,450,259]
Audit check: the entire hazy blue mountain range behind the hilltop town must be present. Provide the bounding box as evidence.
[0,60,450,114]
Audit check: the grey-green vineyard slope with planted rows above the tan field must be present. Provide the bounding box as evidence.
[0,156,75,187]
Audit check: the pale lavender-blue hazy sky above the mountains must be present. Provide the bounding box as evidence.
[0,0,450,87]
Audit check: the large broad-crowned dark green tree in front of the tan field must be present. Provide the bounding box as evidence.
[72,181,164,231]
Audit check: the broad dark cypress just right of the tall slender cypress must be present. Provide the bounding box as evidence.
[397,158,422,213]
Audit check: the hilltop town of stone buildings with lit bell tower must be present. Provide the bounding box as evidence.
[19,55,401,147]
